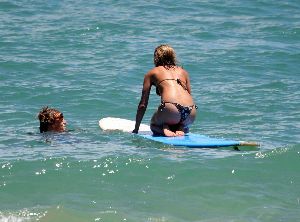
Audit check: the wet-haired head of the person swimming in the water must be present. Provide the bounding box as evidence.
[38,106,66,133]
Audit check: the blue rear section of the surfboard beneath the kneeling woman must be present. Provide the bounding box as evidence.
[137,133,240,148]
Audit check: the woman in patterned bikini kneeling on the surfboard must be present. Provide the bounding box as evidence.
[132,45,197,136]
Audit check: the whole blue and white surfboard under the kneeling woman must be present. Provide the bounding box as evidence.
[99,117,259,148]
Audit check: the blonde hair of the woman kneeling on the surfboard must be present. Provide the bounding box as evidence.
[154,45,177,68]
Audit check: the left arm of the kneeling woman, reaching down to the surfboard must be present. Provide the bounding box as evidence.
[132,72,152,133]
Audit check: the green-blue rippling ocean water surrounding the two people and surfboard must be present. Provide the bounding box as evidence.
[0,0,300,222]
